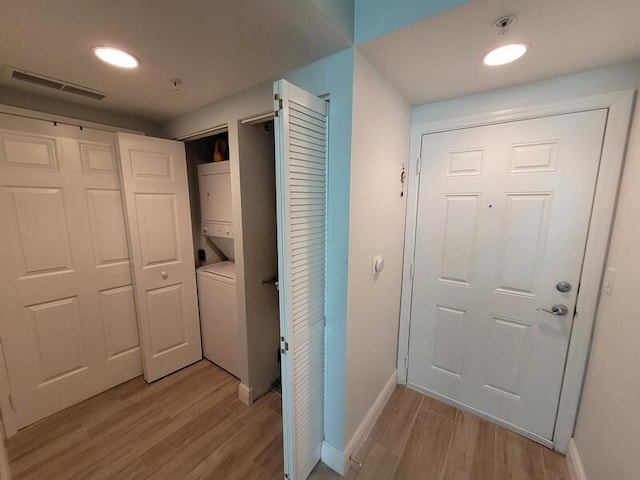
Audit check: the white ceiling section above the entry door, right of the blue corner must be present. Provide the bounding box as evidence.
[358,0,640,105]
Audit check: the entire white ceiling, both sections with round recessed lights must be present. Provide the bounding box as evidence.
[0,0,640,122]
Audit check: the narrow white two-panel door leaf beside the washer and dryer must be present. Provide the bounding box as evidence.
[118,133,202,382]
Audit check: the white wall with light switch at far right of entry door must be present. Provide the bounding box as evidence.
[574,72,640,480]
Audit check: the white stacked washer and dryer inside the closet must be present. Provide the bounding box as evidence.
[196,161,241,377]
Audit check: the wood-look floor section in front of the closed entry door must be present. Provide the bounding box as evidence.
[312,386,569,480]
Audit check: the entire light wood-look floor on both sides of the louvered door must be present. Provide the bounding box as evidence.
[7,360,569,480]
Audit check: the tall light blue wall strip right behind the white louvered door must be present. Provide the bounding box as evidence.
[285,48,354,451]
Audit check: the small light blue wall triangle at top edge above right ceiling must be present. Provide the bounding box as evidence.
[355,0,467,44]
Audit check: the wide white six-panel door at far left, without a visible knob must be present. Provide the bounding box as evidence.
[0,115,142,434]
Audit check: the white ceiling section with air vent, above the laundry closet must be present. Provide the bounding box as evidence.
[0,0,349,121]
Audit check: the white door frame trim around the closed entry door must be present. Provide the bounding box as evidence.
[398,90,635,453]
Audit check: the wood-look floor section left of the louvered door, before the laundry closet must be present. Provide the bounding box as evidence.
[7,360,283,480]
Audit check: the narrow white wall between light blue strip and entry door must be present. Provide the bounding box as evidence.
[344,52,411,445]
